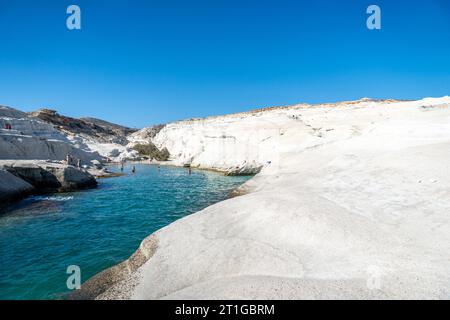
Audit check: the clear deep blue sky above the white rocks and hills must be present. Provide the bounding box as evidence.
[0,0,450,127]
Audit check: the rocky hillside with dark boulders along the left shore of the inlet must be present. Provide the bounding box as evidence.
[0,106,137,211]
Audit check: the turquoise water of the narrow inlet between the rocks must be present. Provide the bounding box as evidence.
[0,165,248,299]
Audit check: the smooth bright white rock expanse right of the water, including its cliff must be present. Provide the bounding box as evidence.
[98,97,450,299]
